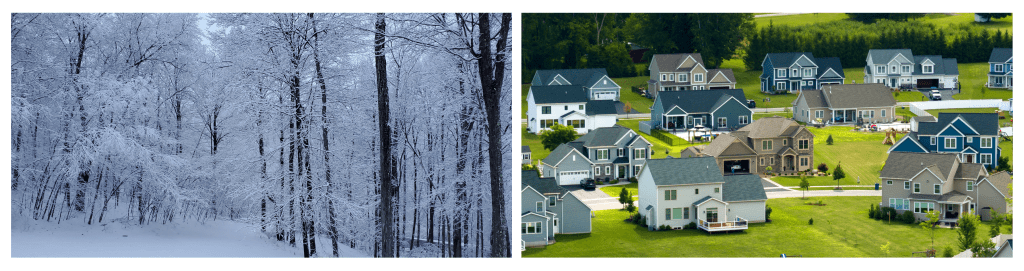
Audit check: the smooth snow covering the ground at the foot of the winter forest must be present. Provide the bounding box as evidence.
[10,215,367,258]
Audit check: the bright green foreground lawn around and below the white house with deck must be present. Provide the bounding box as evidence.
[522,196,990,258]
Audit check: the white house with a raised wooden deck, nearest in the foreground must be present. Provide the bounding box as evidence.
[637,156,768,232]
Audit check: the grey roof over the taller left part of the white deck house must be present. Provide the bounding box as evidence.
[646,156,725,185]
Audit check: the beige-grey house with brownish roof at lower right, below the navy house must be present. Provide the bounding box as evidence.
[879,151,1013,225]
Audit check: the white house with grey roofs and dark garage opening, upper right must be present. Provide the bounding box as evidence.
[864,49,959,89]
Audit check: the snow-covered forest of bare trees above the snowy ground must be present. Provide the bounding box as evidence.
[11,13,514,257]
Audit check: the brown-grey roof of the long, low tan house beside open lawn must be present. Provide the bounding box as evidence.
[821,84,896,108]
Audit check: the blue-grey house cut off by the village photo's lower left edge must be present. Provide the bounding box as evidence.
[521,171,591,246]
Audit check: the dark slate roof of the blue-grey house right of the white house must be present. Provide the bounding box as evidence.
[655,89,746,114]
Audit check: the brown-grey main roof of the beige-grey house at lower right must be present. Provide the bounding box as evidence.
[879,151,959,178]
